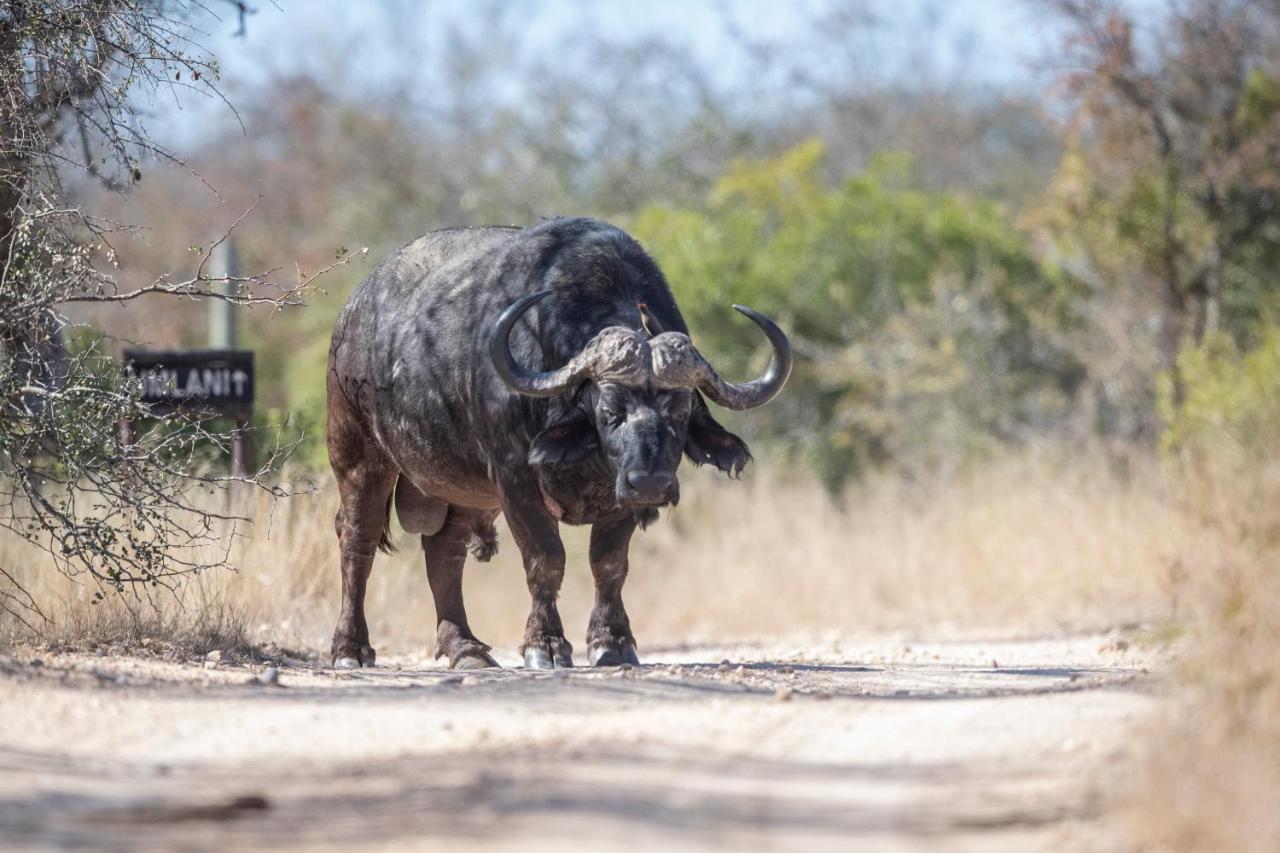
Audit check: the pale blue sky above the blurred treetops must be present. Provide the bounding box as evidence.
[148,0,1051,145]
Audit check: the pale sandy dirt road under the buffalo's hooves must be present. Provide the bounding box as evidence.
[0,635,1157,850]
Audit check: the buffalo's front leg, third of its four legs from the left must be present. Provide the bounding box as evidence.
[503,484,573,670]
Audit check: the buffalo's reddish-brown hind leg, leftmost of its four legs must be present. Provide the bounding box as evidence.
[330,464,396,669]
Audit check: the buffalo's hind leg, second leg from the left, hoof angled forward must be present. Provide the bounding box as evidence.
[422,506,498,670]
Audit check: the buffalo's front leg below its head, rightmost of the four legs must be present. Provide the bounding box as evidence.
[586,512,640,666]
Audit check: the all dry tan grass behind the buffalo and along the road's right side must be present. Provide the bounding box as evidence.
[10,438,1280,850]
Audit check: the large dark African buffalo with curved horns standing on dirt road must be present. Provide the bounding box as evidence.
[328,219,791,669]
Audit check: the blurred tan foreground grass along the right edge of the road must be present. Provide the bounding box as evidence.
[1128,448,1280,853]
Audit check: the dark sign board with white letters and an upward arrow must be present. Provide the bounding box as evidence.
[124,350,253,418]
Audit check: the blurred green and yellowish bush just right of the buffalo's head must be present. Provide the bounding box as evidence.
[632,141,1079,487]
